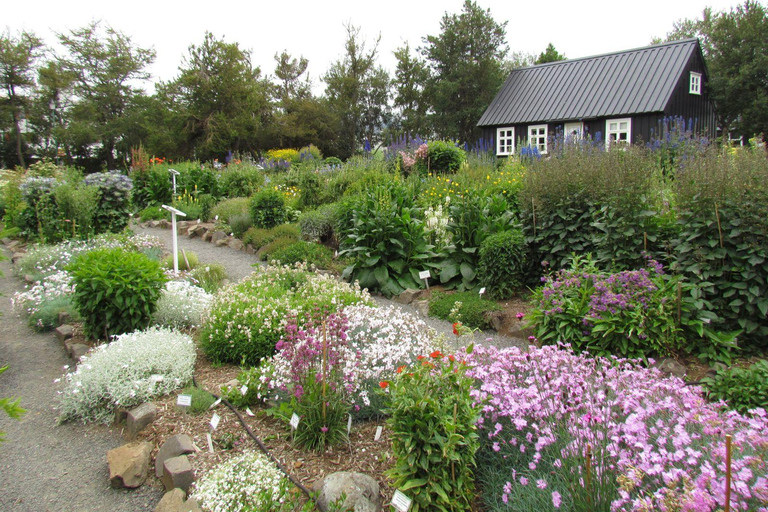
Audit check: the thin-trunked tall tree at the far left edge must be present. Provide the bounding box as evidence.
[0,29,44,167]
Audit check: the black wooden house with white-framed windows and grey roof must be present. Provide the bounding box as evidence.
[477,39,717,156]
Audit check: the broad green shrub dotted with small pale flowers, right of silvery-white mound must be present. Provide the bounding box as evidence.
[200,265,370,366]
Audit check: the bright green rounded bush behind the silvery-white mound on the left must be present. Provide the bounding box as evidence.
[68,248,166,339]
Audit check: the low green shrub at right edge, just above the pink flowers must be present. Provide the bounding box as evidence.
[702,359,768,414]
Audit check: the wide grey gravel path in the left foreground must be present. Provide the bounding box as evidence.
[0,249,162,512]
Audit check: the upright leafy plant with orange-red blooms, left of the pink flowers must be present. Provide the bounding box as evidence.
[381,346,480,512]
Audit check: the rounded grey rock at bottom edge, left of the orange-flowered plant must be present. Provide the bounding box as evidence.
[313,471,381,512]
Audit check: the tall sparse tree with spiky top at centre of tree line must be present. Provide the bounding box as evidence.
[323,24,390,158]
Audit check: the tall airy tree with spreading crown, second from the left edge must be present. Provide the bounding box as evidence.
[57,21,155,168]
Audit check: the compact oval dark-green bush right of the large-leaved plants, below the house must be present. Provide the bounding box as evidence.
[478,229,527,299]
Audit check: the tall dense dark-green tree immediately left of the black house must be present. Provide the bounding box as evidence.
[420,0,508,141]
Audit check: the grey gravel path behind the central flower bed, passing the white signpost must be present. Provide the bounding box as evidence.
[131,225,528,349]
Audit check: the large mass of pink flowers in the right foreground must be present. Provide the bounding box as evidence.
[469,346,768,512]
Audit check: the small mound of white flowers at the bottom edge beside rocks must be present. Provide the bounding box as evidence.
[191,452,288,512]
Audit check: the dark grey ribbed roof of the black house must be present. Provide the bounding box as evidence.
[477,39,701,126]
